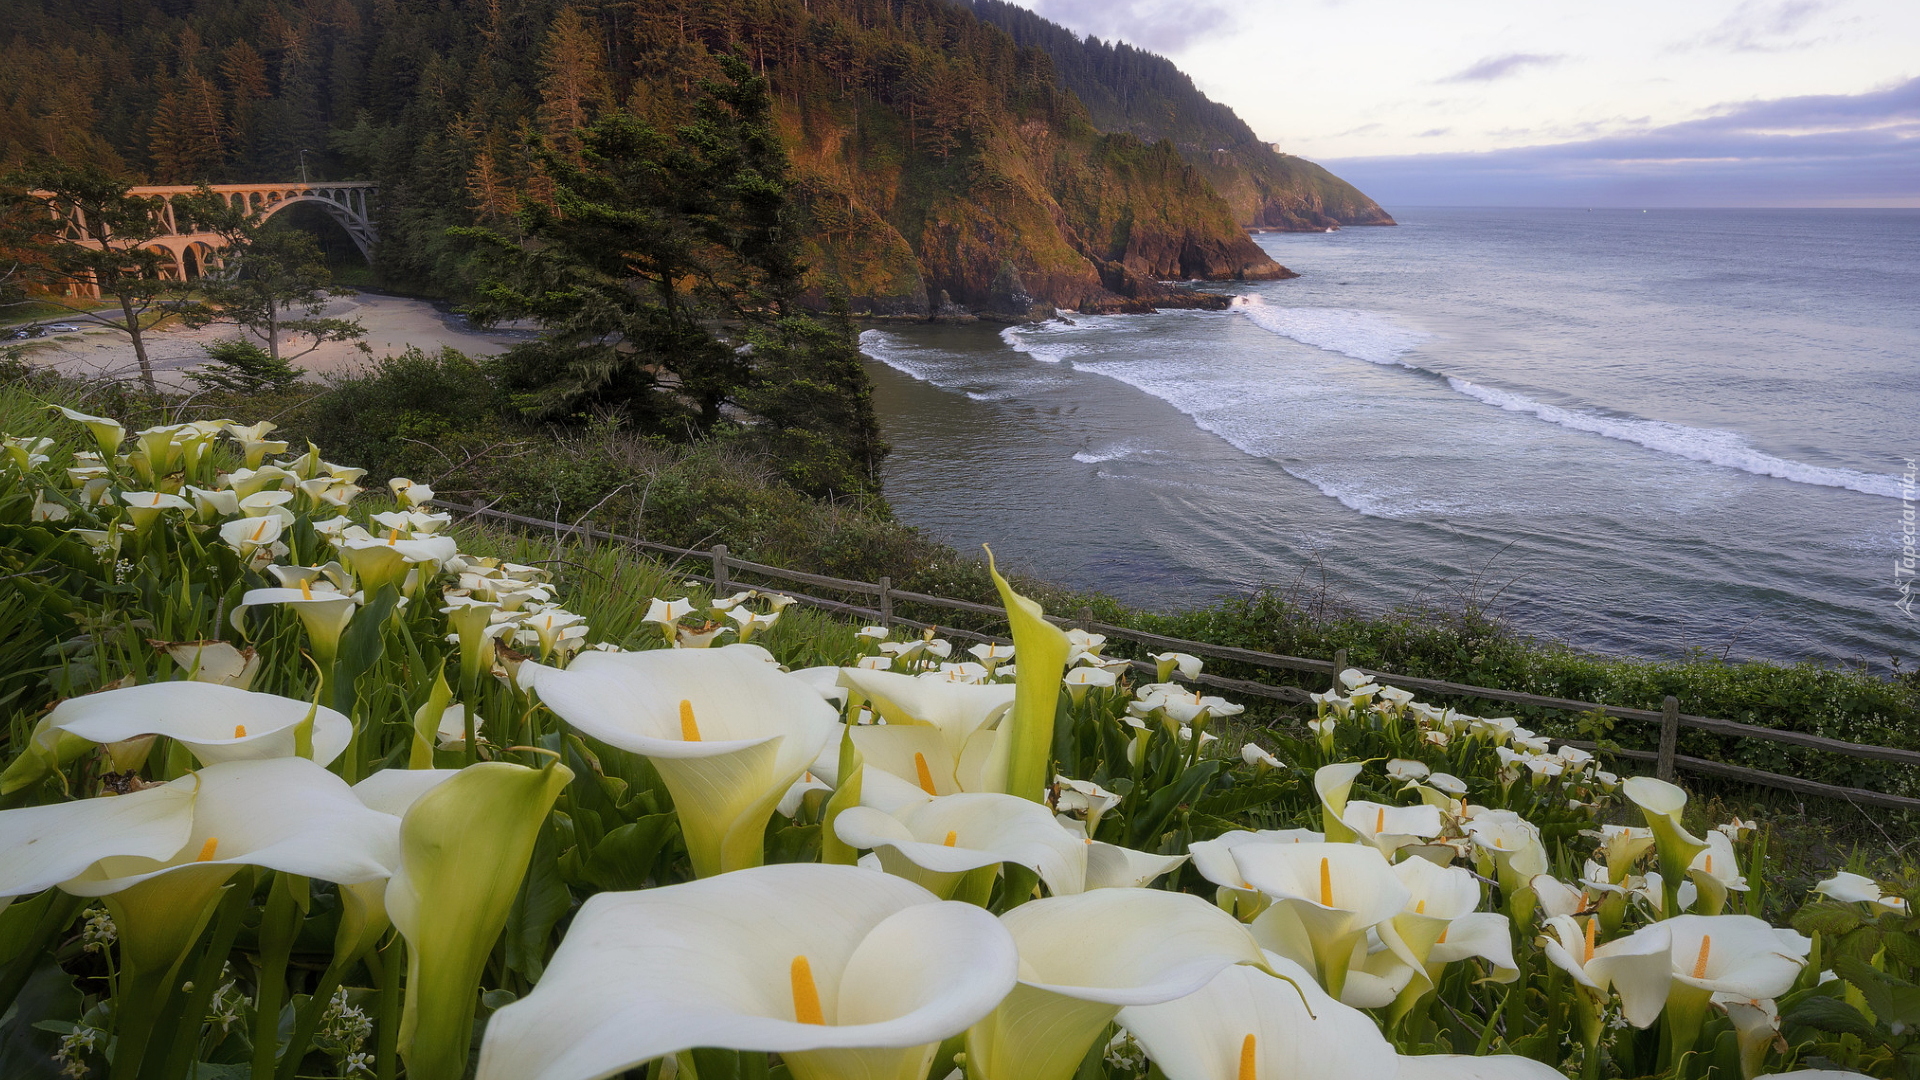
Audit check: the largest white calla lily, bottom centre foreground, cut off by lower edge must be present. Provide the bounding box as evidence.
[478,863,1020,1080]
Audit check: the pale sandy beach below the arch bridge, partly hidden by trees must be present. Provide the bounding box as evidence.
[13,292,534,390]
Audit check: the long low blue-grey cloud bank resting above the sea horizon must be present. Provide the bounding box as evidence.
[1323,79,1920,209]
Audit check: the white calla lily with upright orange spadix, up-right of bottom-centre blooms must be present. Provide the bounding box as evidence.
[1233,844,1413,995]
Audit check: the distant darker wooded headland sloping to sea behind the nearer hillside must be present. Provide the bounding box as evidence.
[960,0,1394,231]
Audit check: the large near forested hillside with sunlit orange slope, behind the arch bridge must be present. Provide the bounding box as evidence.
[0,0,1397,317]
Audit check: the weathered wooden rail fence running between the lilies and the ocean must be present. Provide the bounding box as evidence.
[432,500,1920,811]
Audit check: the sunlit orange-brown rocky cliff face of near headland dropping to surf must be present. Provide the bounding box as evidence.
[787,110,1294,319]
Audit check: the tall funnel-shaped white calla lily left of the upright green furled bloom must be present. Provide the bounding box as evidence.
[520,648,841,876]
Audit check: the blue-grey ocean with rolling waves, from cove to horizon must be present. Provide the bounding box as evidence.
[862,209,1920,671]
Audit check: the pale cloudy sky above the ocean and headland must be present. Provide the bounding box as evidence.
[1020,0,1920,208]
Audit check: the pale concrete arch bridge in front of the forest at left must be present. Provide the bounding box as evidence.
[60,181,380,281]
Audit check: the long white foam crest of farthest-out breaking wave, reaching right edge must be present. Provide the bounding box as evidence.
[1233,296,1901,499]
